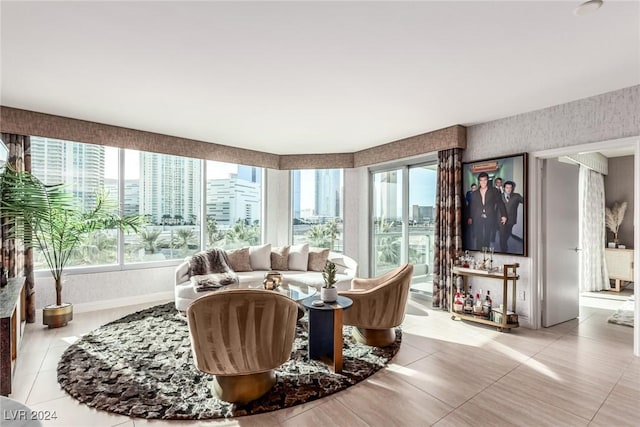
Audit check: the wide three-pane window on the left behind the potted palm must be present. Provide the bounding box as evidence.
[31,137,263,269]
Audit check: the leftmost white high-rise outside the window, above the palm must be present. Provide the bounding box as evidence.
[31,136,105,208]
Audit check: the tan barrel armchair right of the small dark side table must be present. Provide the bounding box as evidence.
[338,264,413,347]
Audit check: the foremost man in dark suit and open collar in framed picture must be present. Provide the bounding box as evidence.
[467,172,507,250]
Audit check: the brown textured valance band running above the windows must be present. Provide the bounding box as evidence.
[0,106,466,169]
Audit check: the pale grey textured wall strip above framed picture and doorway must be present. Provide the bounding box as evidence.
[464,85,640,161]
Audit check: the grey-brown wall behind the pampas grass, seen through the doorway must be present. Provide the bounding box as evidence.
[604,156,634,248]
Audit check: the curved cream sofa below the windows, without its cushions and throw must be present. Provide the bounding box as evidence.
[175,247,358,311]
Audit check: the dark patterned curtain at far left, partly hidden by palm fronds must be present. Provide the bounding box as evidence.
[0,133,36,323]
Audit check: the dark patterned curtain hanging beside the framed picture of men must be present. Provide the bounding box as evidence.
[433,148,462,310]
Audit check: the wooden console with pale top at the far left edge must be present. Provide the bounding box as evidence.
[0,277,26,396]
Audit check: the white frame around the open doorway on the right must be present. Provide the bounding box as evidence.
[529,136,640,356]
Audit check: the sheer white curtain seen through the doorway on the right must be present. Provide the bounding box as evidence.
[579,165,610,292]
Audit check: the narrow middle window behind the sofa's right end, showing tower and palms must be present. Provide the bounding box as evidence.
[291,169,344,252]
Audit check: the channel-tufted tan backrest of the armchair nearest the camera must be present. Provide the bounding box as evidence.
[187,289,298,375]
